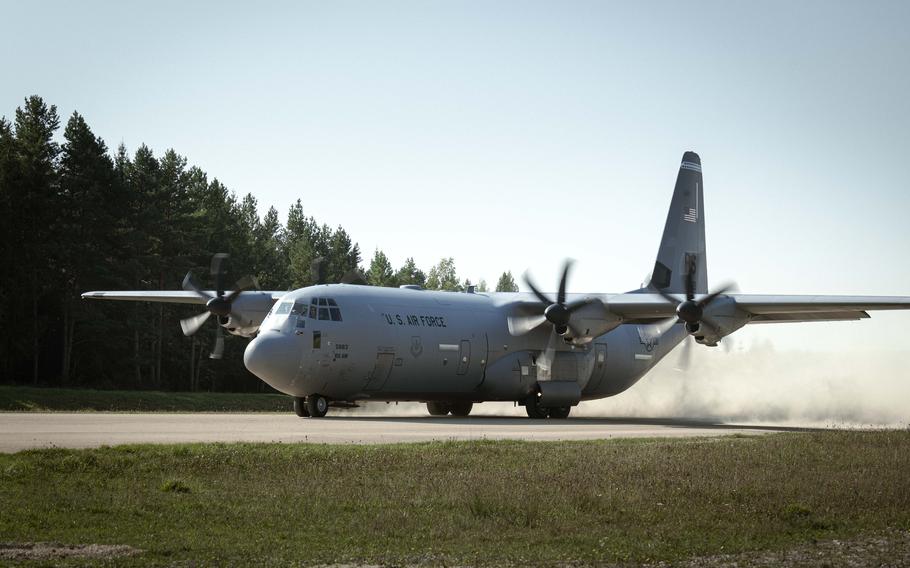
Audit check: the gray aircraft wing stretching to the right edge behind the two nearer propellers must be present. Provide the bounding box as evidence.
[606,293,910,323]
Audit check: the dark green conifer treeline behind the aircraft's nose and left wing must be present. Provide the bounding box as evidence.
[0,96,517,390]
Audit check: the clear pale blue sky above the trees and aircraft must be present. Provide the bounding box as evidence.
[0,1,910,350]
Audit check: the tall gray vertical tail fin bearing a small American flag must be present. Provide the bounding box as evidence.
[648,152,708,294]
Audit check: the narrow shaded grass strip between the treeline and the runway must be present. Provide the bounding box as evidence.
[0,386,291,412]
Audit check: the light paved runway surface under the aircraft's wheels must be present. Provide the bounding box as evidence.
[0,412,787,453]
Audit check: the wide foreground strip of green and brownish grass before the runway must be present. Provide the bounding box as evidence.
[0,430,910,565]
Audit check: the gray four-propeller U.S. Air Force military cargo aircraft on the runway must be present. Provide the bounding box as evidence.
[82,152,910,419]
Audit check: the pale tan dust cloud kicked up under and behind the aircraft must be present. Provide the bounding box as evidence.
[332,344,910,428]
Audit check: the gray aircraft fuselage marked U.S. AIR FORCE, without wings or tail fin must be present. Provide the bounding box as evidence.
[244,284,687,401]
